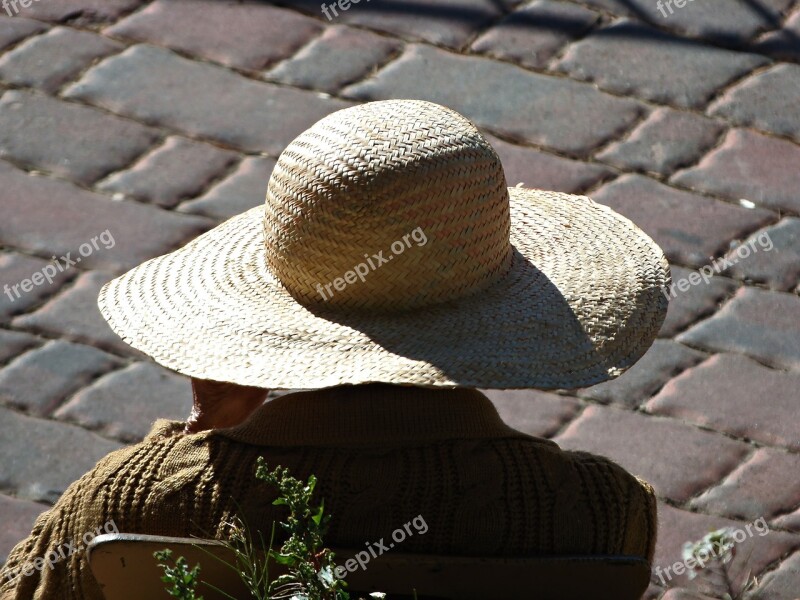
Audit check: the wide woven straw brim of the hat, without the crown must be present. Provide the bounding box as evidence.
[98,188,669,389]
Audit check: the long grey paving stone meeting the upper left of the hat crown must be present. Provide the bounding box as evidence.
[66,45,350,156]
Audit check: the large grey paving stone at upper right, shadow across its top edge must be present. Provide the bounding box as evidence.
[555,20,768,108]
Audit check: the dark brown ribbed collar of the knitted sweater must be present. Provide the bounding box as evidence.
[209,384,530,447]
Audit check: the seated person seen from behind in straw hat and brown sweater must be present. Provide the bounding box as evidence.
[0,100,669,600]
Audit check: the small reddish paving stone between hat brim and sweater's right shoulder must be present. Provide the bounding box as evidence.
[481,390,582,438]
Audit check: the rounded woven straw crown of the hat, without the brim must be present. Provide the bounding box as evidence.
[264,100,512,311]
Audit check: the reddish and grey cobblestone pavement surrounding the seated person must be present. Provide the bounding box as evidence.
[0,0,800,600]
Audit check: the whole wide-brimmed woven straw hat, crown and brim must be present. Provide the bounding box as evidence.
[98,100,669,389]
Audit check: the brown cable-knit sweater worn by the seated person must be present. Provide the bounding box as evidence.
[0,384,656,600]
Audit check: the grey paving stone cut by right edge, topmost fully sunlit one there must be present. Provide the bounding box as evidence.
[710,64,800,140]
